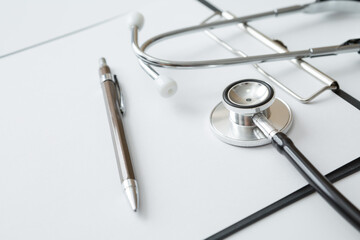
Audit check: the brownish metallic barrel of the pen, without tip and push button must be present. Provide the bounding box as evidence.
[101,80,135,182]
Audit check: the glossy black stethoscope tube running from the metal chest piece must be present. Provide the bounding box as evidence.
[272,133,360,231]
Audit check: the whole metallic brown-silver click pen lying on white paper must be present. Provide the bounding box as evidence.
[99,58,139,212]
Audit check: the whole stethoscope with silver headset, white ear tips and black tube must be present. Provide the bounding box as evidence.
[129,0,360,231]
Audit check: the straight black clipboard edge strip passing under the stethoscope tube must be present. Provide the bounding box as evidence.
[206,157,360,240]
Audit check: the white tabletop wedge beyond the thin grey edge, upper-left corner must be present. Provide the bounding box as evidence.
[0,0,148,57]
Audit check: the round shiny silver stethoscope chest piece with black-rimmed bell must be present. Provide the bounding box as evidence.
[210,79,292,147]
